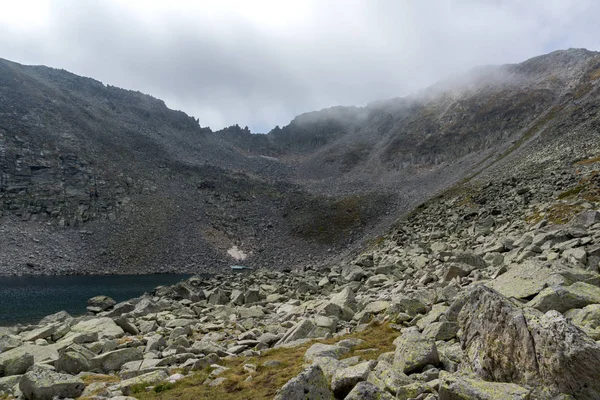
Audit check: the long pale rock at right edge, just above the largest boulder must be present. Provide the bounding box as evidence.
[527,282,600,312]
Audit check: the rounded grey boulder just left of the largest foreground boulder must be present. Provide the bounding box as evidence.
[394,328,440,374]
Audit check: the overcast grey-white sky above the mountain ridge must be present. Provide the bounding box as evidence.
[0,0,600,132]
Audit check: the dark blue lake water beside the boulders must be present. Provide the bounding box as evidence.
[0,274,189,326]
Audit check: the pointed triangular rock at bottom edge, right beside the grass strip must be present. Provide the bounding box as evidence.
[273,365,333,400]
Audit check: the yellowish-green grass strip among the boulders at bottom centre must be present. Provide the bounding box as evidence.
[135,323,398,400]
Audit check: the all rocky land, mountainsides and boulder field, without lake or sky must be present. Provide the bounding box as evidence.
[0,49,600,400]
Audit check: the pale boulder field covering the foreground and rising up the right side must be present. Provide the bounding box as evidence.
[0,160,600,400]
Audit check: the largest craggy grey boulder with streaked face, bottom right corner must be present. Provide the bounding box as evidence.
[446,285,600,400]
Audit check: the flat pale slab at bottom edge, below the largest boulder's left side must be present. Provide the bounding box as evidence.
[439,371,531,400]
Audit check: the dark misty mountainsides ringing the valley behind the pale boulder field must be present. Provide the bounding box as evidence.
[0,50,600,274]
